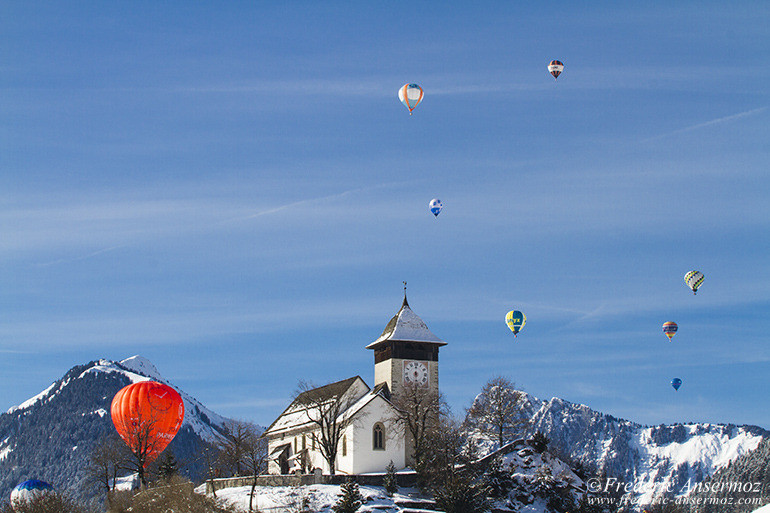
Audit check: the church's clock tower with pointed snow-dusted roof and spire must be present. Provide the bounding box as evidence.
[366,283,446,395]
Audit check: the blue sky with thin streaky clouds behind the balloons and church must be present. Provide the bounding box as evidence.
[0,2,770,428]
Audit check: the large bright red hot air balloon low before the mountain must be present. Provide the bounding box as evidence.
[110,381,184,467]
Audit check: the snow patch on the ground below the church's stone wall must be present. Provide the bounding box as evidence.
[195,484,414,513]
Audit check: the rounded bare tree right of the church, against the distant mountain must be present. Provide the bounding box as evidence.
[465,376,528,447]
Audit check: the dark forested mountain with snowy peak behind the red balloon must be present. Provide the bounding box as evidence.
[0,356,234,497]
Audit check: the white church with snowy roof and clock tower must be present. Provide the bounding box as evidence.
[263,288,446,474]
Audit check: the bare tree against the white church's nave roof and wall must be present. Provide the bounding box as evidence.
[294,378,366,474]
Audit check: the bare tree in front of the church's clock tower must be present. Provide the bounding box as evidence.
[391,382,448,471]
